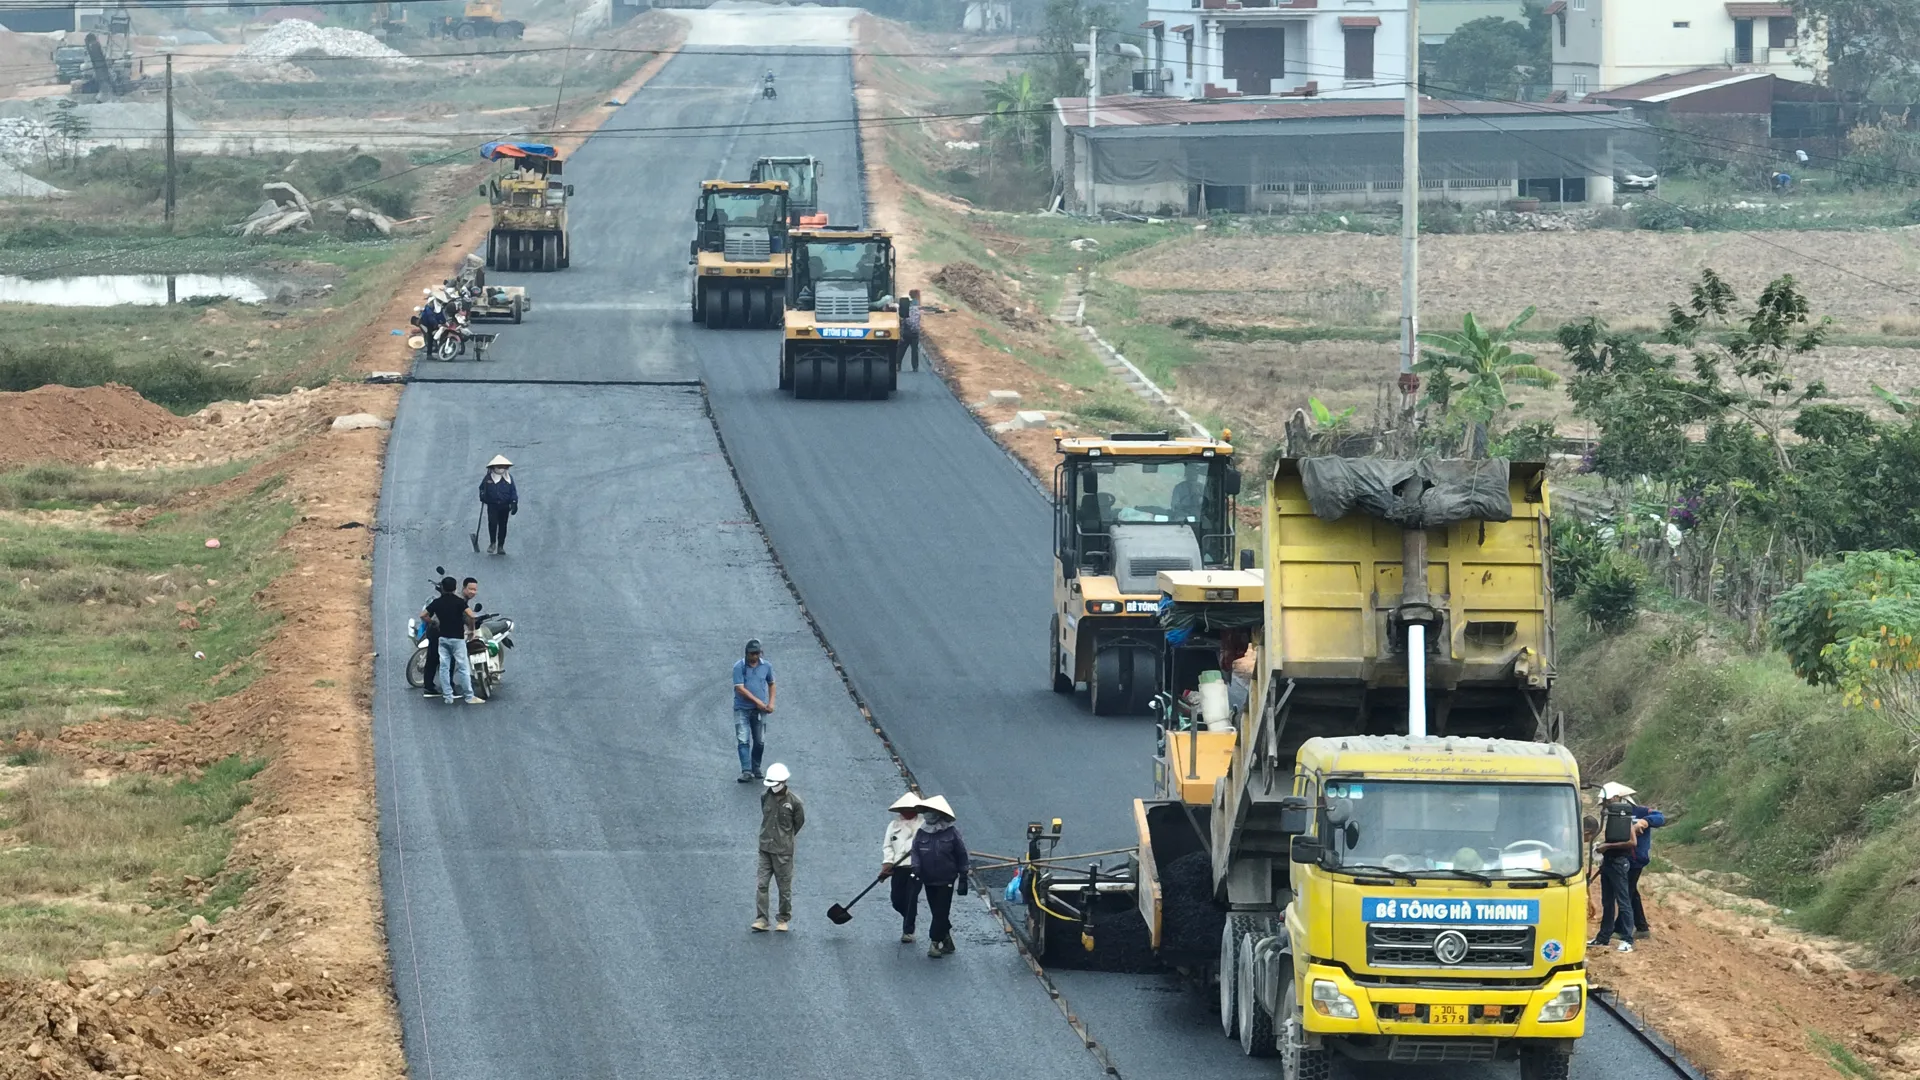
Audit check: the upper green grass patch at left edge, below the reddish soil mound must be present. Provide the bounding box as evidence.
[0,471,294,746]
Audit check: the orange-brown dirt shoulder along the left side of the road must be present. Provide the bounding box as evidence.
[0,21,678,1080]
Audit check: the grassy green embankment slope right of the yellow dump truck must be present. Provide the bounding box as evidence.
[1555,615,1920,974]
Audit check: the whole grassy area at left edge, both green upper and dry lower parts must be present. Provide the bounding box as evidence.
[0,465,294,976]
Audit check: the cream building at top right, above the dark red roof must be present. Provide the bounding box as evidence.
[1548,0,1824,102]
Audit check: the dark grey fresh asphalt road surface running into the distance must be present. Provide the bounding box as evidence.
[374,25,1667,1080]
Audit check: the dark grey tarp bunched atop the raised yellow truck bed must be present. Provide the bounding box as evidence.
[1300,457,1513,528]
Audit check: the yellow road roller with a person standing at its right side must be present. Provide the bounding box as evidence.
[780,229,900,400]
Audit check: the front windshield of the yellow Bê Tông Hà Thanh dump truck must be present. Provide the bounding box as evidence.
[1325,778,1580,876]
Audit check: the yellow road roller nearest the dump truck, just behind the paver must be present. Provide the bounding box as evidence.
[1048,432,1252,717]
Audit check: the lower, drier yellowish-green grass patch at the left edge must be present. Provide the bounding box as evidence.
[0,757,265,978]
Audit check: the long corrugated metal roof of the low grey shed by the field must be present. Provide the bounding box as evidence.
[1054,94,1620,127]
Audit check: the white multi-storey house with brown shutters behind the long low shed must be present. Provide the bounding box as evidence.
[1129,0,1413,98]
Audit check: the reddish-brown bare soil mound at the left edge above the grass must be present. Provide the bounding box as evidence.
[0,382,180,467]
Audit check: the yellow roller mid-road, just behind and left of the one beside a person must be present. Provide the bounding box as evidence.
[687,181,789,331]
